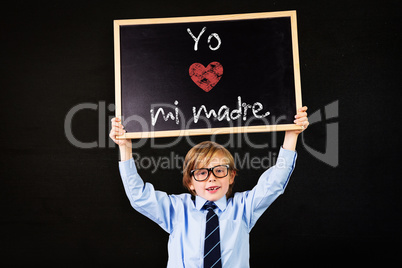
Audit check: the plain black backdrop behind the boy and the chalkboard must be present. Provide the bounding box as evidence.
[0,0,402,267]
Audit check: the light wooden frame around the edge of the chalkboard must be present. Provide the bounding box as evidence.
[114,10,302,139]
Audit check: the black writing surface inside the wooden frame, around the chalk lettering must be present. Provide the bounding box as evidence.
[120,17,296,132]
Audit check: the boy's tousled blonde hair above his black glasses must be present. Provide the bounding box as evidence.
[183,141,237,197]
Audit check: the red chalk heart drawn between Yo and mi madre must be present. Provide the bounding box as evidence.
[188,61,223,92]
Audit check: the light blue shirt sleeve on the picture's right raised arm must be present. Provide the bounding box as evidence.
[242,147,297,231]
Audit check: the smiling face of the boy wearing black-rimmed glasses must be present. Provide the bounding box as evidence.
[190,155,235,201]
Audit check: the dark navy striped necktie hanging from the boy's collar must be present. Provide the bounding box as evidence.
[204,201,222,268]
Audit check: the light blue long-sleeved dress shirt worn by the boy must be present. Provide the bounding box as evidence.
[119,148,297,268]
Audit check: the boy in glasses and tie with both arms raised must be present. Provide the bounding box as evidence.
[110,107,309,268]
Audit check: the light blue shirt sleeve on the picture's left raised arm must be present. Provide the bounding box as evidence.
[119,158,174,233]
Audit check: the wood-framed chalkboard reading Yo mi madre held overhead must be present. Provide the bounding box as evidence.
[114,11,302,138]
